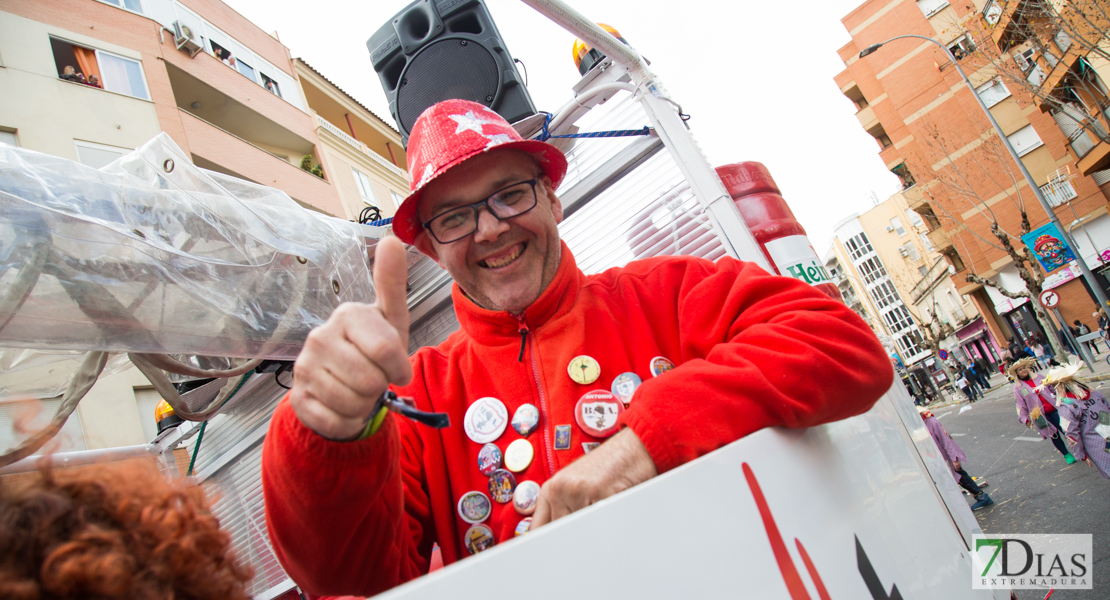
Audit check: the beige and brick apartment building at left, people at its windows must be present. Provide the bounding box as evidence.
[0,0,408,451]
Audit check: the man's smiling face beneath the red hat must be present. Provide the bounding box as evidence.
[416,149,563,314]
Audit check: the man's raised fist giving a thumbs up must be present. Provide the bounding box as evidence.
[290,237,413,439]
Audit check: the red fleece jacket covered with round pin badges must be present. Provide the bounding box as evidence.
[262,245,894,596]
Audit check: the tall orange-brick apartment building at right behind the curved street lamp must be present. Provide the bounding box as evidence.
[836,0,1110,354]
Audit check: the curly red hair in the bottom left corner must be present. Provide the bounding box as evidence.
[0,459,252,600]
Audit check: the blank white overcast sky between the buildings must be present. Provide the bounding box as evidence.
[224,0,899,250]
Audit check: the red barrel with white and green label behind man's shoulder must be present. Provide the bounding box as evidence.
[717,161,844,302]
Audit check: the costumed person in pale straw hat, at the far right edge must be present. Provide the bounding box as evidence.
[1042,363,1110,479]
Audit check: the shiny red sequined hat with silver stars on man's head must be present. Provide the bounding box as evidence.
[393,100,566,244]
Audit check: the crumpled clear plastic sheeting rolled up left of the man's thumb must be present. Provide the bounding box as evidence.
[0,133,374,359]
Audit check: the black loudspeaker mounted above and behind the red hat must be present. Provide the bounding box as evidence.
[366,0,536,146]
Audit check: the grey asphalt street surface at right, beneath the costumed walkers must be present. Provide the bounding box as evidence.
[929,361,1110,600]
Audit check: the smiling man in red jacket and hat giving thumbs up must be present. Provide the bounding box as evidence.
[262,100,894,596]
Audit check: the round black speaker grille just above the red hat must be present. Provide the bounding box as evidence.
[397,39,497,134]
